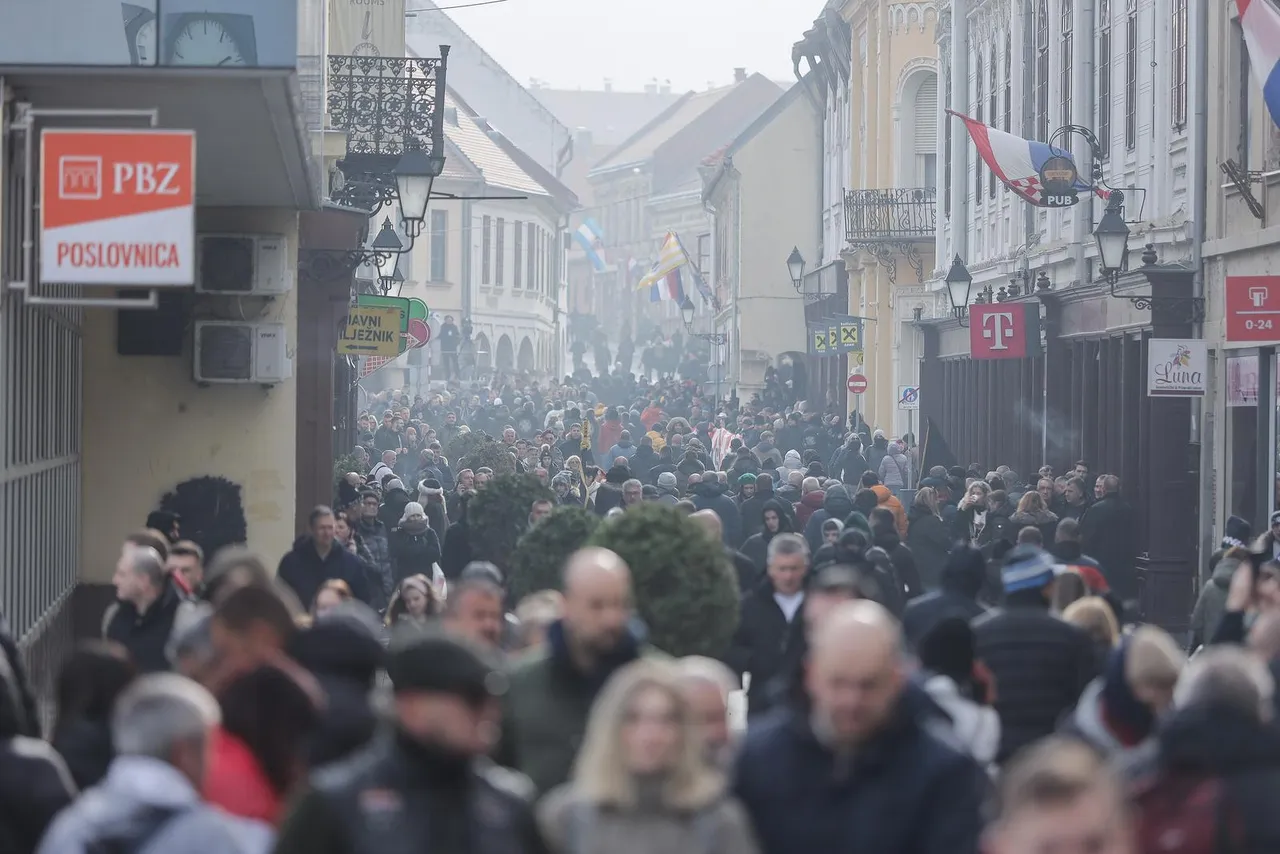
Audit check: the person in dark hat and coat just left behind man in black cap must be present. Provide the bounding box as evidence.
[287,602,383,768]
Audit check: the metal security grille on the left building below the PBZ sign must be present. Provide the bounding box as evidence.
[0,100,82,698]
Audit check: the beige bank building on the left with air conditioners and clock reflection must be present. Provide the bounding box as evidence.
[0,0,320,689]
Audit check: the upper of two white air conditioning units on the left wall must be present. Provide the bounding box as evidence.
[196,234,291,297]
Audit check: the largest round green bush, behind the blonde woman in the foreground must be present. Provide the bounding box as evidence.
[590,502,739,657]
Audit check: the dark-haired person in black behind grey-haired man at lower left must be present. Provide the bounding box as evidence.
[52,641,137,790]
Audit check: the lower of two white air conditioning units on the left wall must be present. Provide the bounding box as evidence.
[193,320,293,385]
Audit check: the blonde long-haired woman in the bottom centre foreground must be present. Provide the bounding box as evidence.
[538,659,759,854]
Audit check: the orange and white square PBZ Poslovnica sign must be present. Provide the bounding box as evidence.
[40,128,196,287]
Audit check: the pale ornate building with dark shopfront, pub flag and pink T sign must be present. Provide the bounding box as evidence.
[920,0,1208,627]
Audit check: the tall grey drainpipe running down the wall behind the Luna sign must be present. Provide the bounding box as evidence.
[1187,0,1208,554]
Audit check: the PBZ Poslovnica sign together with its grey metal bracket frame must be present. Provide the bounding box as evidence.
[0,102,196,309]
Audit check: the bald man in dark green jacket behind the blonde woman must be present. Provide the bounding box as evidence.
[497,548,644,794]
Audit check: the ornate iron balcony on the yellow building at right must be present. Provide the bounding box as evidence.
[845,187,937,283]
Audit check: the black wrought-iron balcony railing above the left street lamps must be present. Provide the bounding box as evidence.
[328,55,445,155]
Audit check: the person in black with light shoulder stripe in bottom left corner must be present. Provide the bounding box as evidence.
[0,665,77,854]
